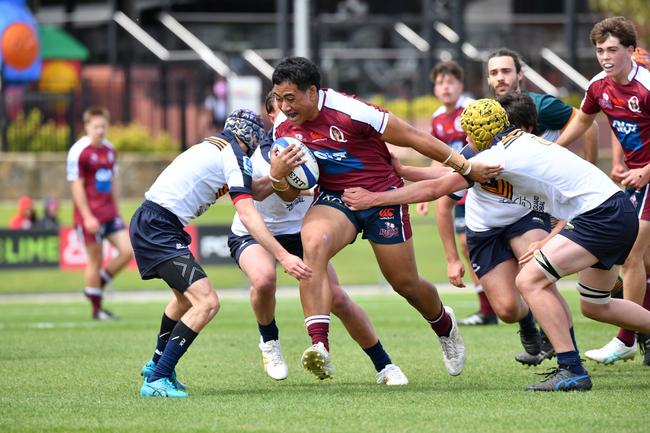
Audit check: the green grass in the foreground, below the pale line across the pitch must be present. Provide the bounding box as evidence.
[0,291,650,433]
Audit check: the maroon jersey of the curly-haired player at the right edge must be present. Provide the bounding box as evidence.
[580,62,650,168]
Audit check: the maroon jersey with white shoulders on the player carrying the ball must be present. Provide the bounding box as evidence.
[273,89,403,191]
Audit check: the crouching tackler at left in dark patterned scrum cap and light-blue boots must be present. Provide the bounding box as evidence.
[129,110,311,397]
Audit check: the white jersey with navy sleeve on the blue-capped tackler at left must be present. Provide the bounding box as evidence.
[144,131,253,226]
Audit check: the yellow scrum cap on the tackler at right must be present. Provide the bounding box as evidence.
[460,98,510,150]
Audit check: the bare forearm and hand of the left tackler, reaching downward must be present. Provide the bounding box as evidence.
[235,197,311,280]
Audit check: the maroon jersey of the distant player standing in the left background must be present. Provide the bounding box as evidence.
[67,137,119,224]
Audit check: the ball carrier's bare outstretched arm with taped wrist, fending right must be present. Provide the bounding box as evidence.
[382,114,502,183]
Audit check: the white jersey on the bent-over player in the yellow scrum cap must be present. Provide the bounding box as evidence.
[467,129,620,226]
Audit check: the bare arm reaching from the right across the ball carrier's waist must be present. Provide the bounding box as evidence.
[343,173,468,210]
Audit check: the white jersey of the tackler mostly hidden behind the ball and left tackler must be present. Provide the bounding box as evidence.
[230,134,312,236]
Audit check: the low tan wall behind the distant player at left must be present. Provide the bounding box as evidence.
[0,153,176,200]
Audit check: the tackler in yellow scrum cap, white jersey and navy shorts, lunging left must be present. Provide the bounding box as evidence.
[340,94,650,391]
